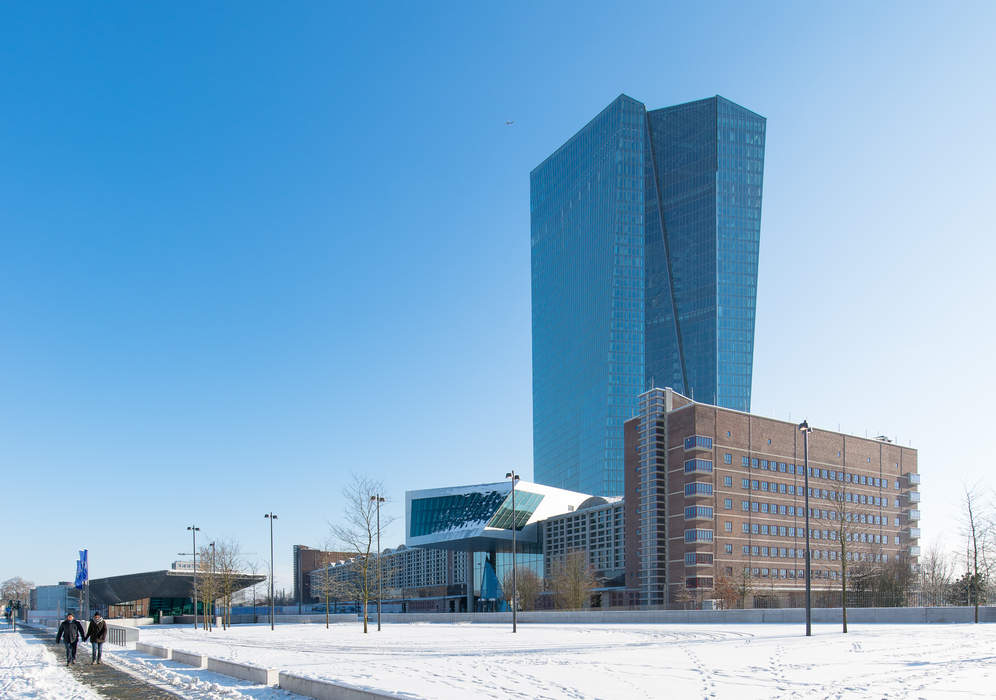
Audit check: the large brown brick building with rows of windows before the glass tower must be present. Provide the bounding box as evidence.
[624,389,920,606]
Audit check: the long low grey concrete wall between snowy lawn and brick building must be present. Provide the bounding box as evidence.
[368,607,996,624]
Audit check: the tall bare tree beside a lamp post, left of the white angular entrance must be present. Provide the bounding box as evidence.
[330,474,393,634]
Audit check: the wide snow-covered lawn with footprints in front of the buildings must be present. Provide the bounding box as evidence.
[132,623,996,700]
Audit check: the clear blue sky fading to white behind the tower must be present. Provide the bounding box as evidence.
[0,2,996,587]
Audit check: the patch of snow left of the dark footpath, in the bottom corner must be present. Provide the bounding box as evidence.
[0,628,100,700]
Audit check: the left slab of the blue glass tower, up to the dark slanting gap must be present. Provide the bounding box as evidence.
[530,96,646,495]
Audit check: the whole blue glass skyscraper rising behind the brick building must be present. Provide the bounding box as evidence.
[530,95,765,495]
